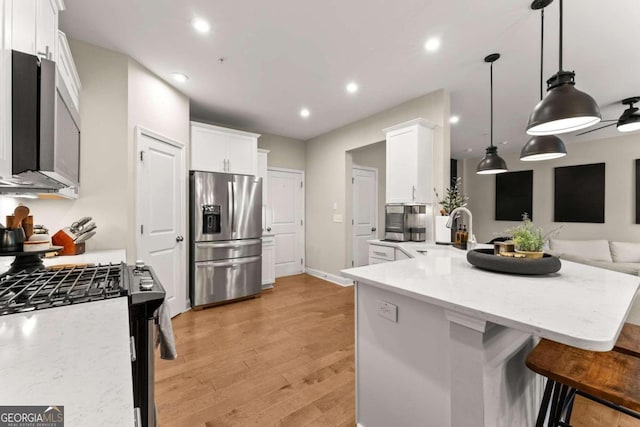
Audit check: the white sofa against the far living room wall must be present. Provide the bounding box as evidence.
[545,239,640,325]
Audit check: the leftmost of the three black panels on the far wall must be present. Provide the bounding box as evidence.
[496,170,533,221]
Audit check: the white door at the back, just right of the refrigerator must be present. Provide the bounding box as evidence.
[267,169,304,277]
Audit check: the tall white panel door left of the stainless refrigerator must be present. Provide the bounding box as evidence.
[136,129,187,316]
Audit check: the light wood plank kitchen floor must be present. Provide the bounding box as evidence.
[156,275,640,427]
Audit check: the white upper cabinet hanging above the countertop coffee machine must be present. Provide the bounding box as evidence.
[384,119,435,203]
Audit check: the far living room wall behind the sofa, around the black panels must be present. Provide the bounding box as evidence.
[463,134,640,242]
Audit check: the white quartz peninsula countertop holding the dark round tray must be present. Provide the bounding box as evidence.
[342,241,639,351]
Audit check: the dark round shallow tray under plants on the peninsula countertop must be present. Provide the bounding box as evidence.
[467,249,562,276]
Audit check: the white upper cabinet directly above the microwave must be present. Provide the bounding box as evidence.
[12,0,58,61]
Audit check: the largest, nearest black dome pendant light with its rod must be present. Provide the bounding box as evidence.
[527,0,602,135]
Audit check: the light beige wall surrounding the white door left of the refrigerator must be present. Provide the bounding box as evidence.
[25,40,189,262]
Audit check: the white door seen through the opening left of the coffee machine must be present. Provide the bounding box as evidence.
[351,166,378,267]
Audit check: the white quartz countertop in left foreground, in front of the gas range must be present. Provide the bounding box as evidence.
[0,297,134,427]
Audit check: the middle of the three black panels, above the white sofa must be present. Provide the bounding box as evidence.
[553,163,605,223]
